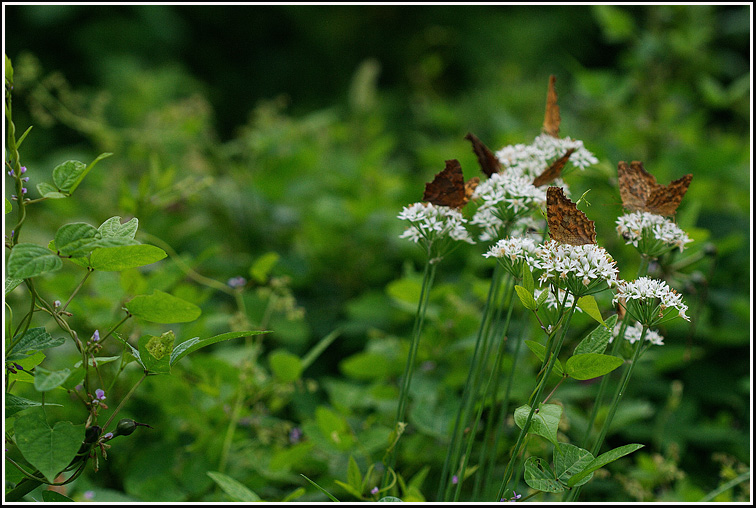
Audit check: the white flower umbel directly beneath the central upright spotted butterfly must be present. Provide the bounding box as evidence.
[534,240,618,298]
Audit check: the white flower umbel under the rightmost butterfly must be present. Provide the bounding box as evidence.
[617,212,693,258]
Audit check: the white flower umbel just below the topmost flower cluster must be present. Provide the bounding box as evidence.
[470,171,546,241]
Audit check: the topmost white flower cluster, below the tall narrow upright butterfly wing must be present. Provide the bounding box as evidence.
[496,134,598,181]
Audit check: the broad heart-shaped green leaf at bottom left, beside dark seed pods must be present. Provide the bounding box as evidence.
[14,410,84,482]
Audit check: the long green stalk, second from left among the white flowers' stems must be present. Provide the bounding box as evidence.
[438,263,503,501]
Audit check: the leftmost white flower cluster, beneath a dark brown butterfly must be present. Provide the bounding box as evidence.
[398,203,475,243]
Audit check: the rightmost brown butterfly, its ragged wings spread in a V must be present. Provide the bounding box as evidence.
[617,161,693,215]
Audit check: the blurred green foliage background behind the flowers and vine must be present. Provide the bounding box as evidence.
[4,5,751,501]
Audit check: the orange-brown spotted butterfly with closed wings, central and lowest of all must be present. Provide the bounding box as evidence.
[546,187,596,245]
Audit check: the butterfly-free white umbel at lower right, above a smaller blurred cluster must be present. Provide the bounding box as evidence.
[614,277,690,328]
